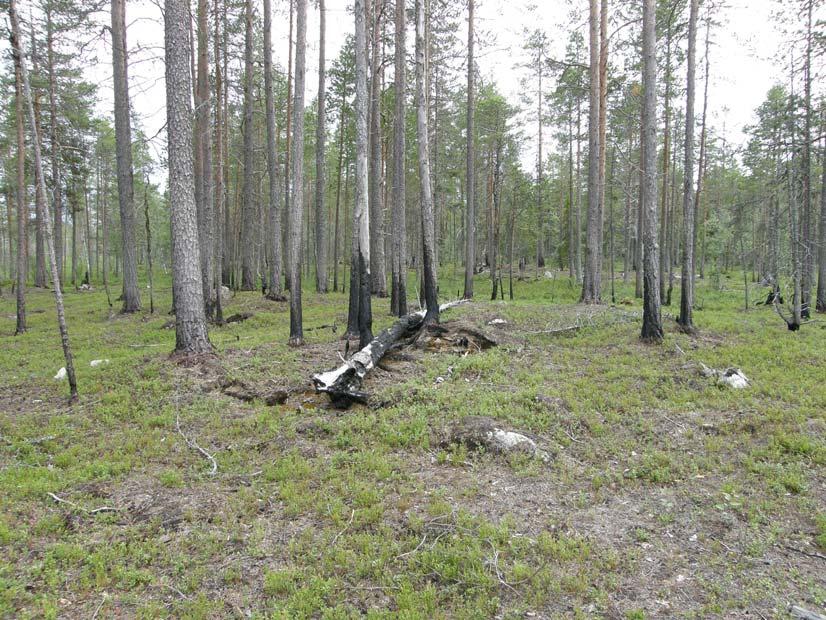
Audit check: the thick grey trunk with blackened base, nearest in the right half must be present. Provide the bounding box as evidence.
[642,0,663,342]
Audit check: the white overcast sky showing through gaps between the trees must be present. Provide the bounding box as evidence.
[69,0,812,170]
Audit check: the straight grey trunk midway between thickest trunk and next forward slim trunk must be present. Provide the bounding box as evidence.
[240,0,257,291]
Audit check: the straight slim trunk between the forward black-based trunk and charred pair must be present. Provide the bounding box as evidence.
[315,0,327,293]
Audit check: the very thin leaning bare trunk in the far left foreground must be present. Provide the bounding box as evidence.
[9,0,77,400]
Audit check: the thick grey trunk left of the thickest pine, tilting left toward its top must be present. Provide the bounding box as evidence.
[112,0,141,313]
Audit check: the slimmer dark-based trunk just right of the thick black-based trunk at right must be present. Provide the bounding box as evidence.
[677,0,700,331]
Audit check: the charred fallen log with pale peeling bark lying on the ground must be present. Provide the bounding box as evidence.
[313,300,466,409]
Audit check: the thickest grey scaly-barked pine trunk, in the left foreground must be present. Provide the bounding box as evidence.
[164,0,212,354]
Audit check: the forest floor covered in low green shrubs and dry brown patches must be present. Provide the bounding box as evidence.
[0,274,826,618]
